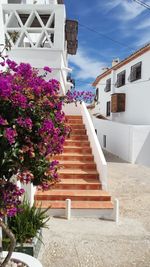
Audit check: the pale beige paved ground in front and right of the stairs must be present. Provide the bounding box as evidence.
[39,153,150,267]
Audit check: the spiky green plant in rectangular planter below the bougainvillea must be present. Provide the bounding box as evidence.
[3,200,49,257]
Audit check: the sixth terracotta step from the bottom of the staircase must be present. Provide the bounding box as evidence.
[53,153,94,162]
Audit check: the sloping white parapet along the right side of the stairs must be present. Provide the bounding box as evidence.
[80,102,108,191]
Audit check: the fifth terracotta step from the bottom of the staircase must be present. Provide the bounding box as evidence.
[59,160,96,170]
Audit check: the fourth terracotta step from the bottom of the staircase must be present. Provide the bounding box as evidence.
[58,169,99,179]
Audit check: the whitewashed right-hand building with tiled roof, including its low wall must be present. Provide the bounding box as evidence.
[92,44,150,166]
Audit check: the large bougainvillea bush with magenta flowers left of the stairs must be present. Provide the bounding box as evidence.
[0,59,69,220]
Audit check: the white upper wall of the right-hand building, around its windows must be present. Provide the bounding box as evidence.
[93,51,150,125]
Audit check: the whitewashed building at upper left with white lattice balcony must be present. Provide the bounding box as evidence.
[0,0,78,94]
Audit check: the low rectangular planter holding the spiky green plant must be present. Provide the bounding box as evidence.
[14,230,42,258]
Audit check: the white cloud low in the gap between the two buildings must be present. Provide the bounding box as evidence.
[69,48,105,80]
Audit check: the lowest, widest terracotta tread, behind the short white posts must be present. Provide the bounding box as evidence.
[35,200,113,209]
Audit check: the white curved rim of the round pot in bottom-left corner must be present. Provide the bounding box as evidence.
[2,251,43,267]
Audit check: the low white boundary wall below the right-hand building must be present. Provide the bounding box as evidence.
[93,118,150,166]
